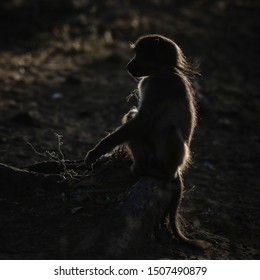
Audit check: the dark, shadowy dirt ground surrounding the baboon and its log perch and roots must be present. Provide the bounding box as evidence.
[0,0,260,259]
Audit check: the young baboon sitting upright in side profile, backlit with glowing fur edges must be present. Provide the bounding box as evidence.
[85,34,209,247]
